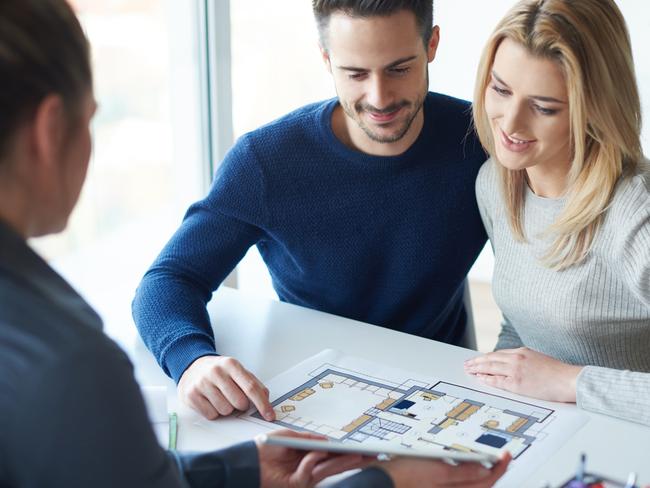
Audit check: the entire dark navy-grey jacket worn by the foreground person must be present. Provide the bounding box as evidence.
[0,222,392,488]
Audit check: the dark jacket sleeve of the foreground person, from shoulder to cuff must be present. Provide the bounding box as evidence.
[5,343,259,488]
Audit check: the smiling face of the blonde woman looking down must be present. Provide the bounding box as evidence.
[485,38,572,173]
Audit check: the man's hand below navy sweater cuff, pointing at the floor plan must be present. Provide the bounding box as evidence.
[178,356,275,422]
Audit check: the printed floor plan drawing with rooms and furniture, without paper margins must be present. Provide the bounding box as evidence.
[248,364,553,458]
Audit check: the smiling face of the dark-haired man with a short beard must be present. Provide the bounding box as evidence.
[323,10,438,154]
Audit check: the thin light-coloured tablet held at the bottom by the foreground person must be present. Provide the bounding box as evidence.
[262,435,499,465]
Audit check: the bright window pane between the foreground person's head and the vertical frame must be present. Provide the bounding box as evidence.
[33,0,203,346]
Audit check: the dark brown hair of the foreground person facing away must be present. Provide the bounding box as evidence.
[0,0,92,161]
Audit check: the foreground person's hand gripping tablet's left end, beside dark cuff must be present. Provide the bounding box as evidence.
[255,429,369,488]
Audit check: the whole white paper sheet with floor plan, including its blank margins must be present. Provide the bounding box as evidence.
[243,350,586,486]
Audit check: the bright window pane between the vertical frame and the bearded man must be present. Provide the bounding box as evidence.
[230,0,336,298]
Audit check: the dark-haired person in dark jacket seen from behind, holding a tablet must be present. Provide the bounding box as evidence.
[0,0,507,488]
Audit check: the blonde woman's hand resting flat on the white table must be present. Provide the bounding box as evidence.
[465,347,582,403]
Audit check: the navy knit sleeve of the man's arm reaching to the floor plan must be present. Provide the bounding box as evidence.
[132,137,268,382]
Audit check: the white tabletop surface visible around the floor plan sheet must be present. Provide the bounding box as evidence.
[128,287,650,487]
